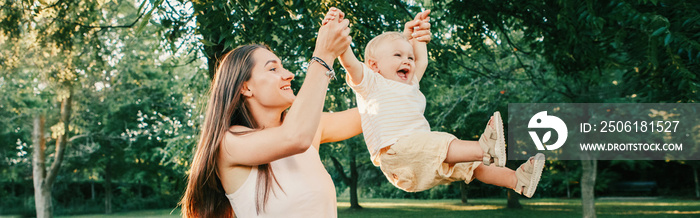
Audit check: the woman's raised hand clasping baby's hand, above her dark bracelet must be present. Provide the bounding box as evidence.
[314,7,352,63]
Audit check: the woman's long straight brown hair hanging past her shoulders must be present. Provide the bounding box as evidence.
[180,44,279,217]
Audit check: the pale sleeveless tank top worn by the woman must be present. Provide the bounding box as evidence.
[226,146,338,218]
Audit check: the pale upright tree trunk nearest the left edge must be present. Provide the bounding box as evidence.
[32,115,52,218]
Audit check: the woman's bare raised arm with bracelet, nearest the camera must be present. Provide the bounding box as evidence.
[221,8,351,166]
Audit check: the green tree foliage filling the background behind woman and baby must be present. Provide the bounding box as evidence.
[0,0,700,216]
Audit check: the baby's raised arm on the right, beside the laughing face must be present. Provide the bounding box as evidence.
[404,10,431,81]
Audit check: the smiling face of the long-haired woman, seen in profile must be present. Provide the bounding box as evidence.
[243,48,296,109]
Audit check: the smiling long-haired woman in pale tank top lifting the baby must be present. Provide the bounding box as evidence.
[181,8,361,217]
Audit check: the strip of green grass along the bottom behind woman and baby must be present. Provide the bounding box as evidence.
[0,198,700,218]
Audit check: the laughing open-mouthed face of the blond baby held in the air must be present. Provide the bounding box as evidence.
[372,39,416,84]
